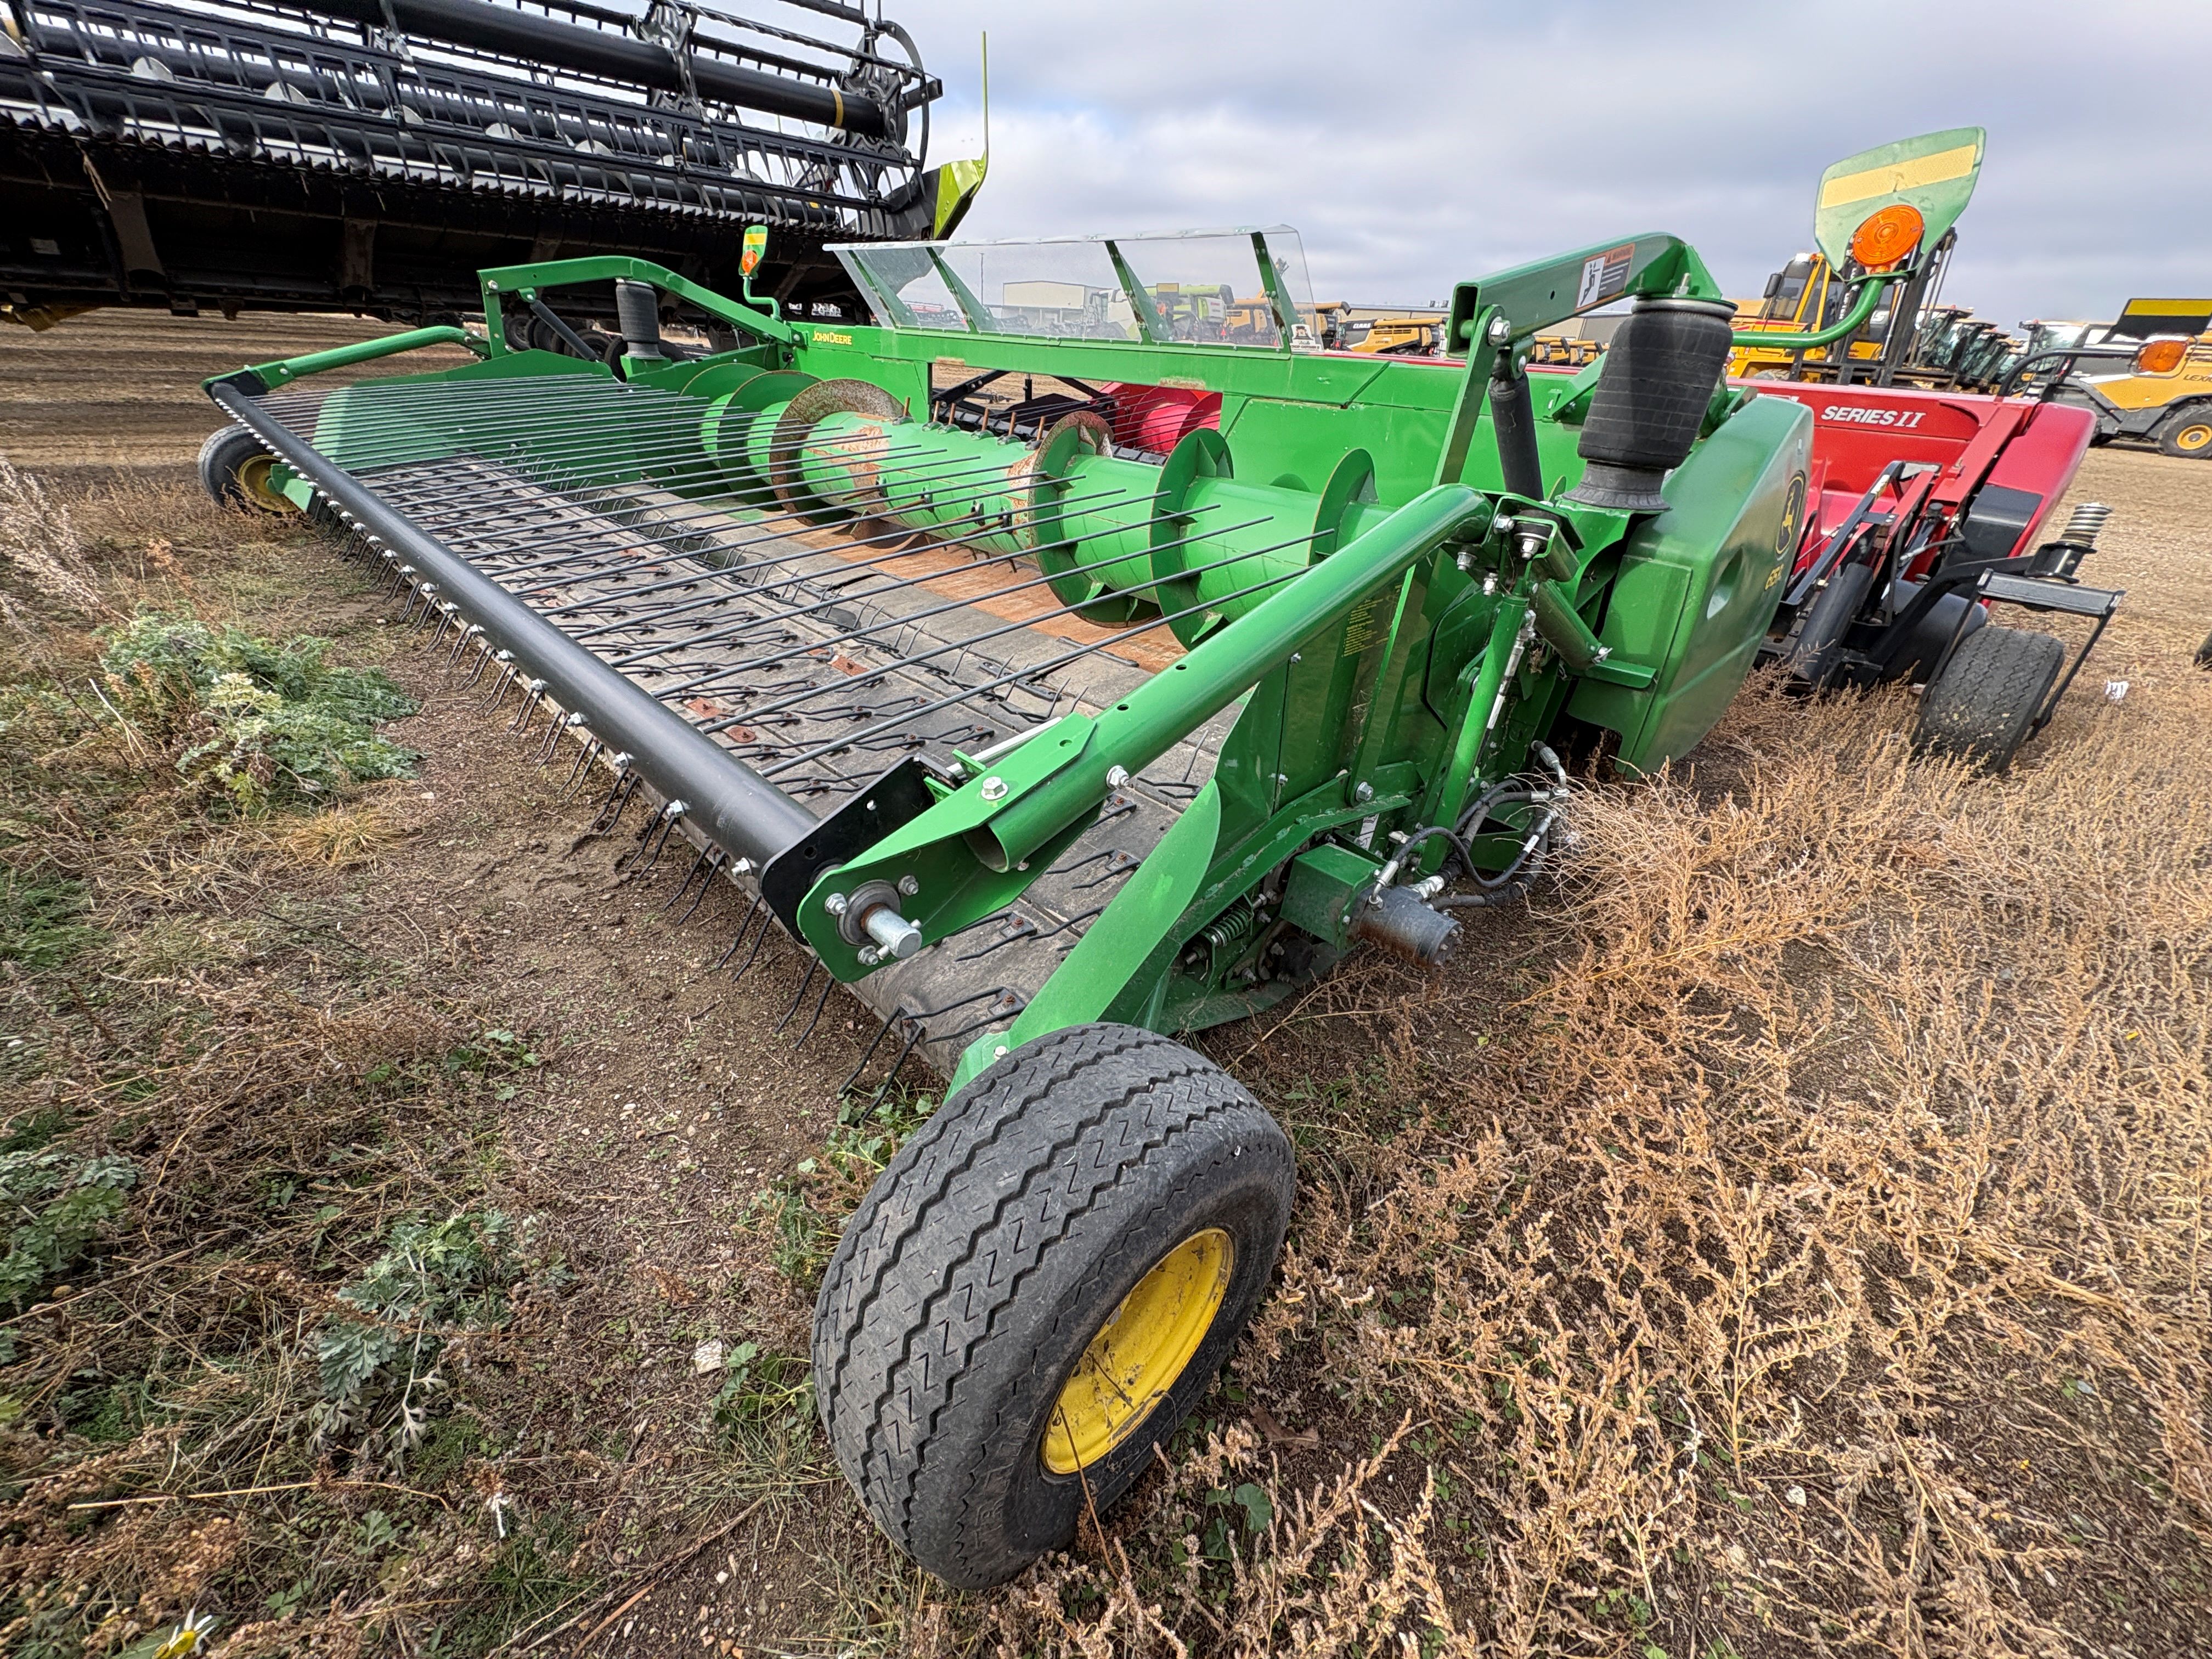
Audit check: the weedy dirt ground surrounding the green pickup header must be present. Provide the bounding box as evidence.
[0,317,2212,1659]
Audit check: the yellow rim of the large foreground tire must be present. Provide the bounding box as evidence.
[1044,1228,1237,1475]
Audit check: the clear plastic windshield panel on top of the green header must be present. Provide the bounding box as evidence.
[832,225,1321,352]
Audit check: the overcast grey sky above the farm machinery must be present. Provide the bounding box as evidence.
[887,0,2212,328]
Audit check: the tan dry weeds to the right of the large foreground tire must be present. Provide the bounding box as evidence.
[907,670,2212,1659]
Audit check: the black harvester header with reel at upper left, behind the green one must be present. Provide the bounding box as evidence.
[0,0,982,334]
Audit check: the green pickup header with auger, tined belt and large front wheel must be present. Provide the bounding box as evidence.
[210,218,1849,1584]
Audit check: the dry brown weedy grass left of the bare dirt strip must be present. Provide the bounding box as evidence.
[0,469,591,1659]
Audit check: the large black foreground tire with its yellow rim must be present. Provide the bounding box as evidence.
[814,1024,1294,1588]
